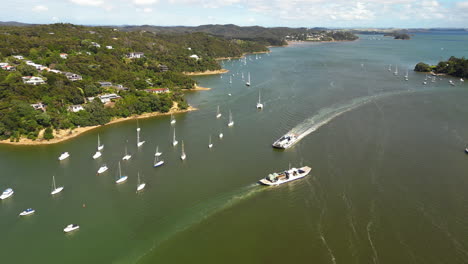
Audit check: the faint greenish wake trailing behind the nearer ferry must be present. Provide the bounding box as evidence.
[135,183,268,263]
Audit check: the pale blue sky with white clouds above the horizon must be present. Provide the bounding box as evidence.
[0,0,468,28]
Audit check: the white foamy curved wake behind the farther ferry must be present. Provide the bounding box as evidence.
[287,91,411,144]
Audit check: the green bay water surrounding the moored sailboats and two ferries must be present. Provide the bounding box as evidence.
[0,32,468,263]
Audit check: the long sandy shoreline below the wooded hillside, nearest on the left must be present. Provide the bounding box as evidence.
[0,103,198,146]
